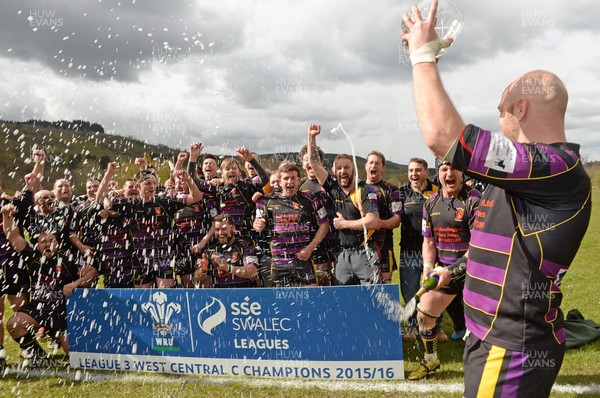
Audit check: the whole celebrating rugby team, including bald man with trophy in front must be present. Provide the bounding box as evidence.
[0,1,591,396]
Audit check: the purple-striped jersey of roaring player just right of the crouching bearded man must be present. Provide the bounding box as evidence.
[256,192,327,266]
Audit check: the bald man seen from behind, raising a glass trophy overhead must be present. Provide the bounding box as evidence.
[402,0,591,397]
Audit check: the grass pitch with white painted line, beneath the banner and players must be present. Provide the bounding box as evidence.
[0,189,600,398]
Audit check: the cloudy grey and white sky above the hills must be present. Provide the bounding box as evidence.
[0,0,600,163]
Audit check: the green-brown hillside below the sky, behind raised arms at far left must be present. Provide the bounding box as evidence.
[0,121,179,195]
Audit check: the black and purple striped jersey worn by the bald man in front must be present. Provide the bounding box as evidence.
[447,125,591,351]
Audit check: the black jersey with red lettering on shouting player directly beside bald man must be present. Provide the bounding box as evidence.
[422,185,481,265]
